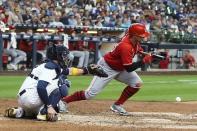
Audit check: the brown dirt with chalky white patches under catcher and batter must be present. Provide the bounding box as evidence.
[0,99,197,131]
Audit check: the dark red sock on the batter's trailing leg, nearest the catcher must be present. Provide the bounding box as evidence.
[63,91,86,103]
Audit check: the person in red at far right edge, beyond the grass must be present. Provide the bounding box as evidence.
[180,50,196,69]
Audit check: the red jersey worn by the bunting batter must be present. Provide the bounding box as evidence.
[104,35,143,71]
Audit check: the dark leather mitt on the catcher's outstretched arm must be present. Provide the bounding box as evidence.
[84,64,108,77]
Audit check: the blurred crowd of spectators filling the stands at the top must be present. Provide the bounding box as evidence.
[0,0,197,70]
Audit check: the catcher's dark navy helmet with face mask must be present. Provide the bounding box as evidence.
[46,45,72,68]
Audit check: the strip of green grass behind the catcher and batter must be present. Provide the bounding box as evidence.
[0,75,197,101]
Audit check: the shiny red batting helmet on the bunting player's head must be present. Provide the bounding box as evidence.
[128,23,150,38]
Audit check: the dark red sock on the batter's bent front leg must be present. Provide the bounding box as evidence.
[115,86,139,105]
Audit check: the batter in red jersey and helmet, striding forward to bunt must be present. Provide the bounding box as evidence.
[63,23,152,115]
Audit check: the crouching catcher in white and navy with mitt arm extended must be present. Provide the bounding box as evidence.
[5,45,108,121]
